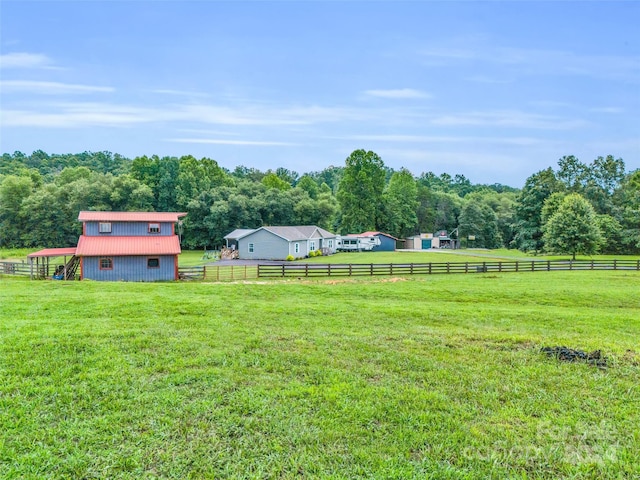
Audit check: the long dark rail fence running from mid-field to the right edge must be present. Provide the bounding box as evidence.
[258,260,640,278]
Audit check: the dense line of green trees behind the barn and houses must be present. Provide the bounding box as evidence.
[0,150,640,254]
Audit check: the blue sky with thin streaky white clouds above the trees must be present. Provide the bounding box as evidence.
[0,0,640,187]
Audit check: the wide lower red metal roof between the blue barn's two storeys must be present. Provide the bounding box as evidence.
[76,235,180,257]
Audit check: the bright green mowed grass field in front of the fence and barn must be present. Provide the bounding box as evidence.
[0,271,640,479]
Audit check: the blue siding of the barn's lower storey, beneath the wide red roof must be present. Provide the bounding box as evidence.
[82,255,176,282]
